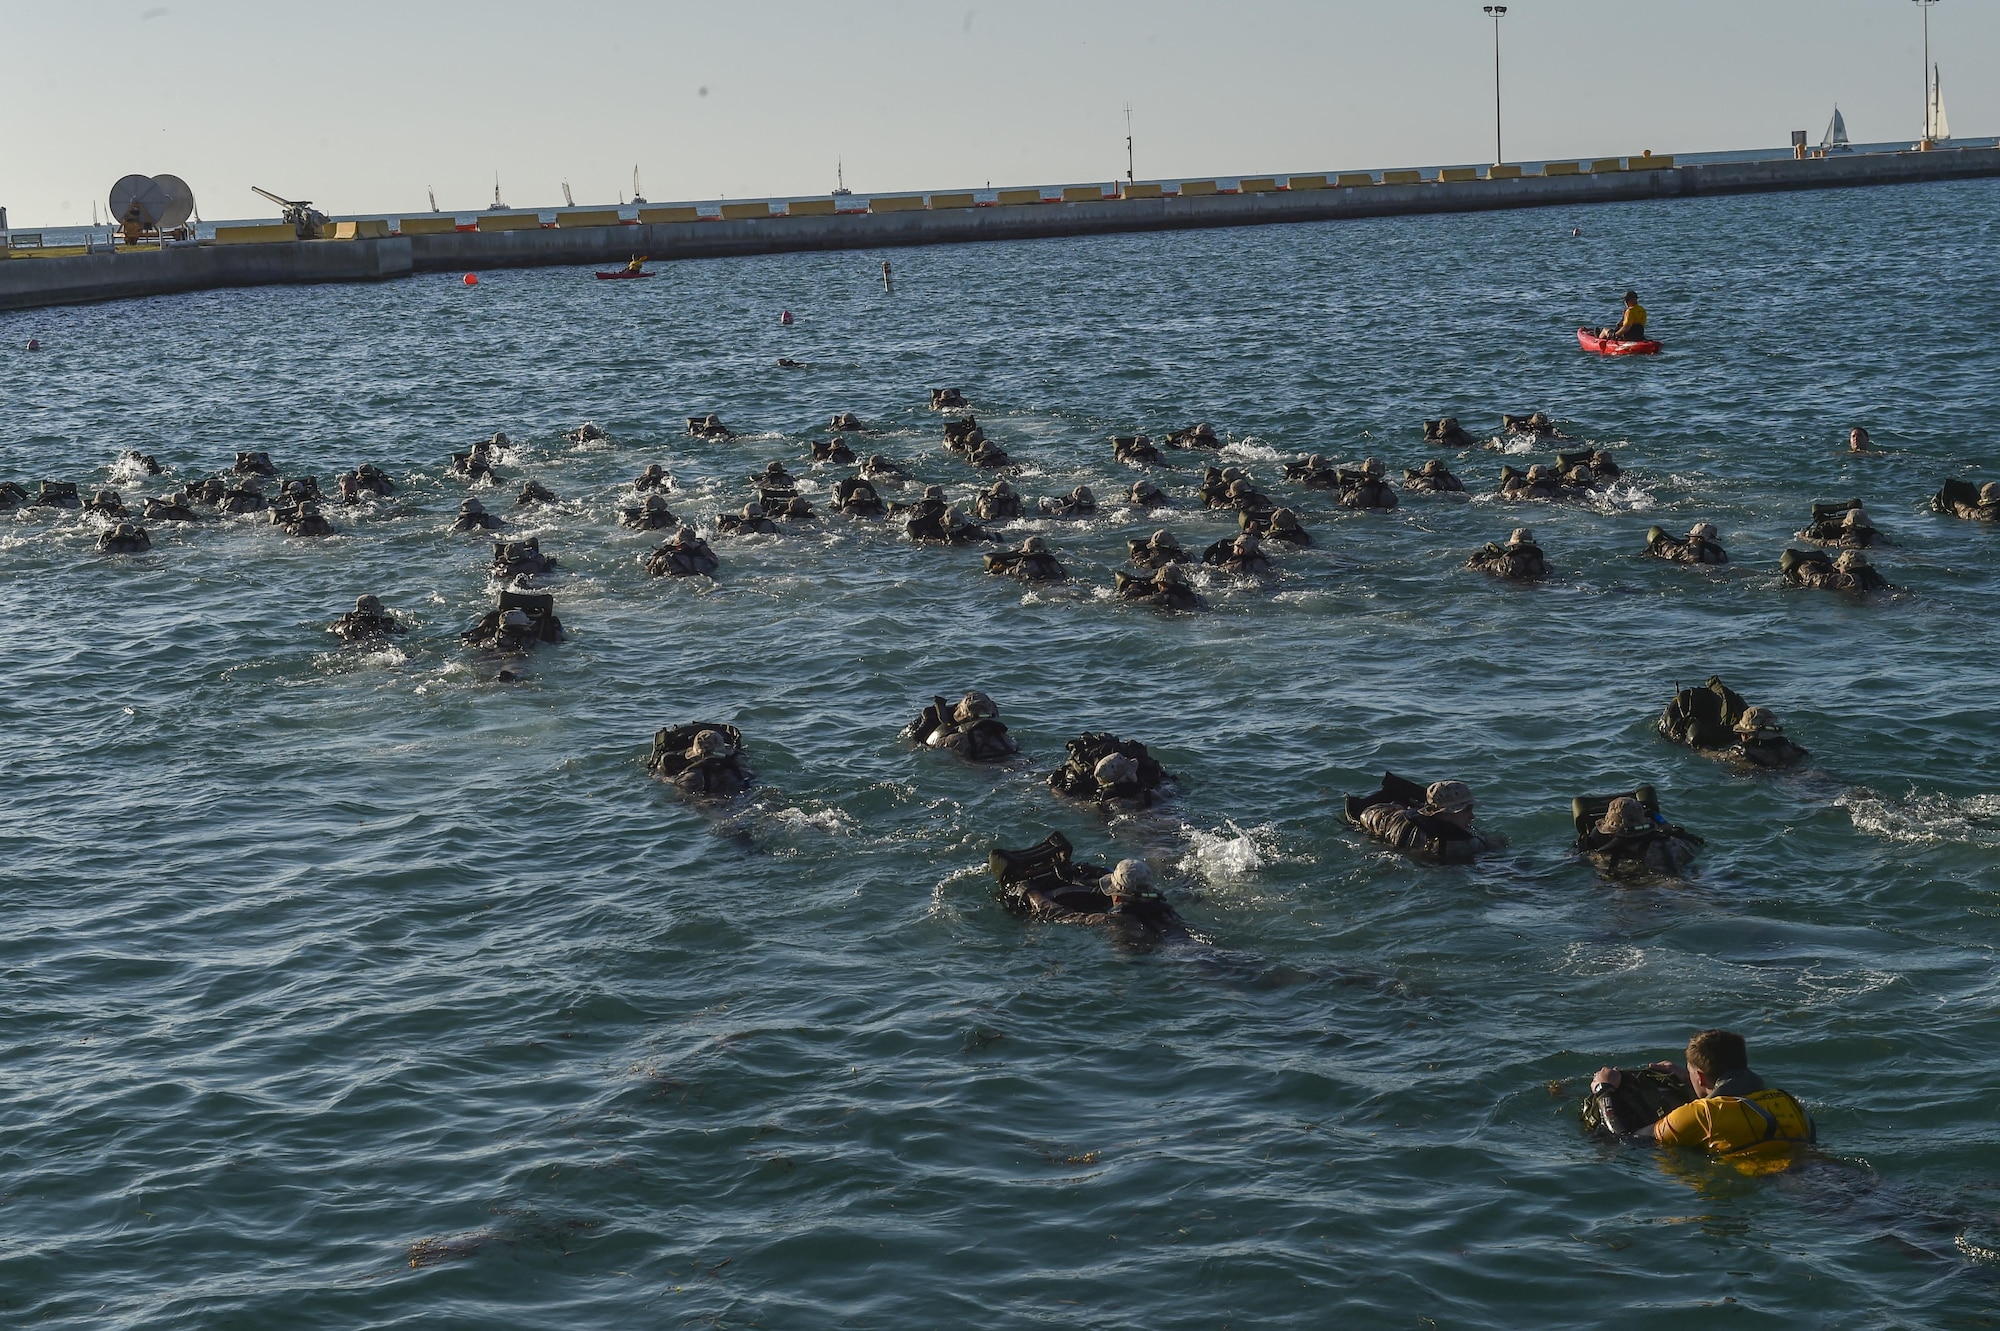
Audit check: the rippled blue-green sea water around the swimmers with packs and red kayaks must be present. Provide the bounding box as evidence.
[0,184,2000,1329]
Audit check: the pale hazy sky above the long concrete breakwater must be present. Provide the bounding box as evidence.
[0,0,2000,226]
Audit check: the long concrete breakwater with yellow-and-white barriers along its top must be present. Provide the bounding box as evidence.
[0,148,2000,310]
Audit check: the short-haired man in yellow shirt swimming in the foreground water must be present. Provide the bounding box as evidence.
[1590,1031,1818,1167]
